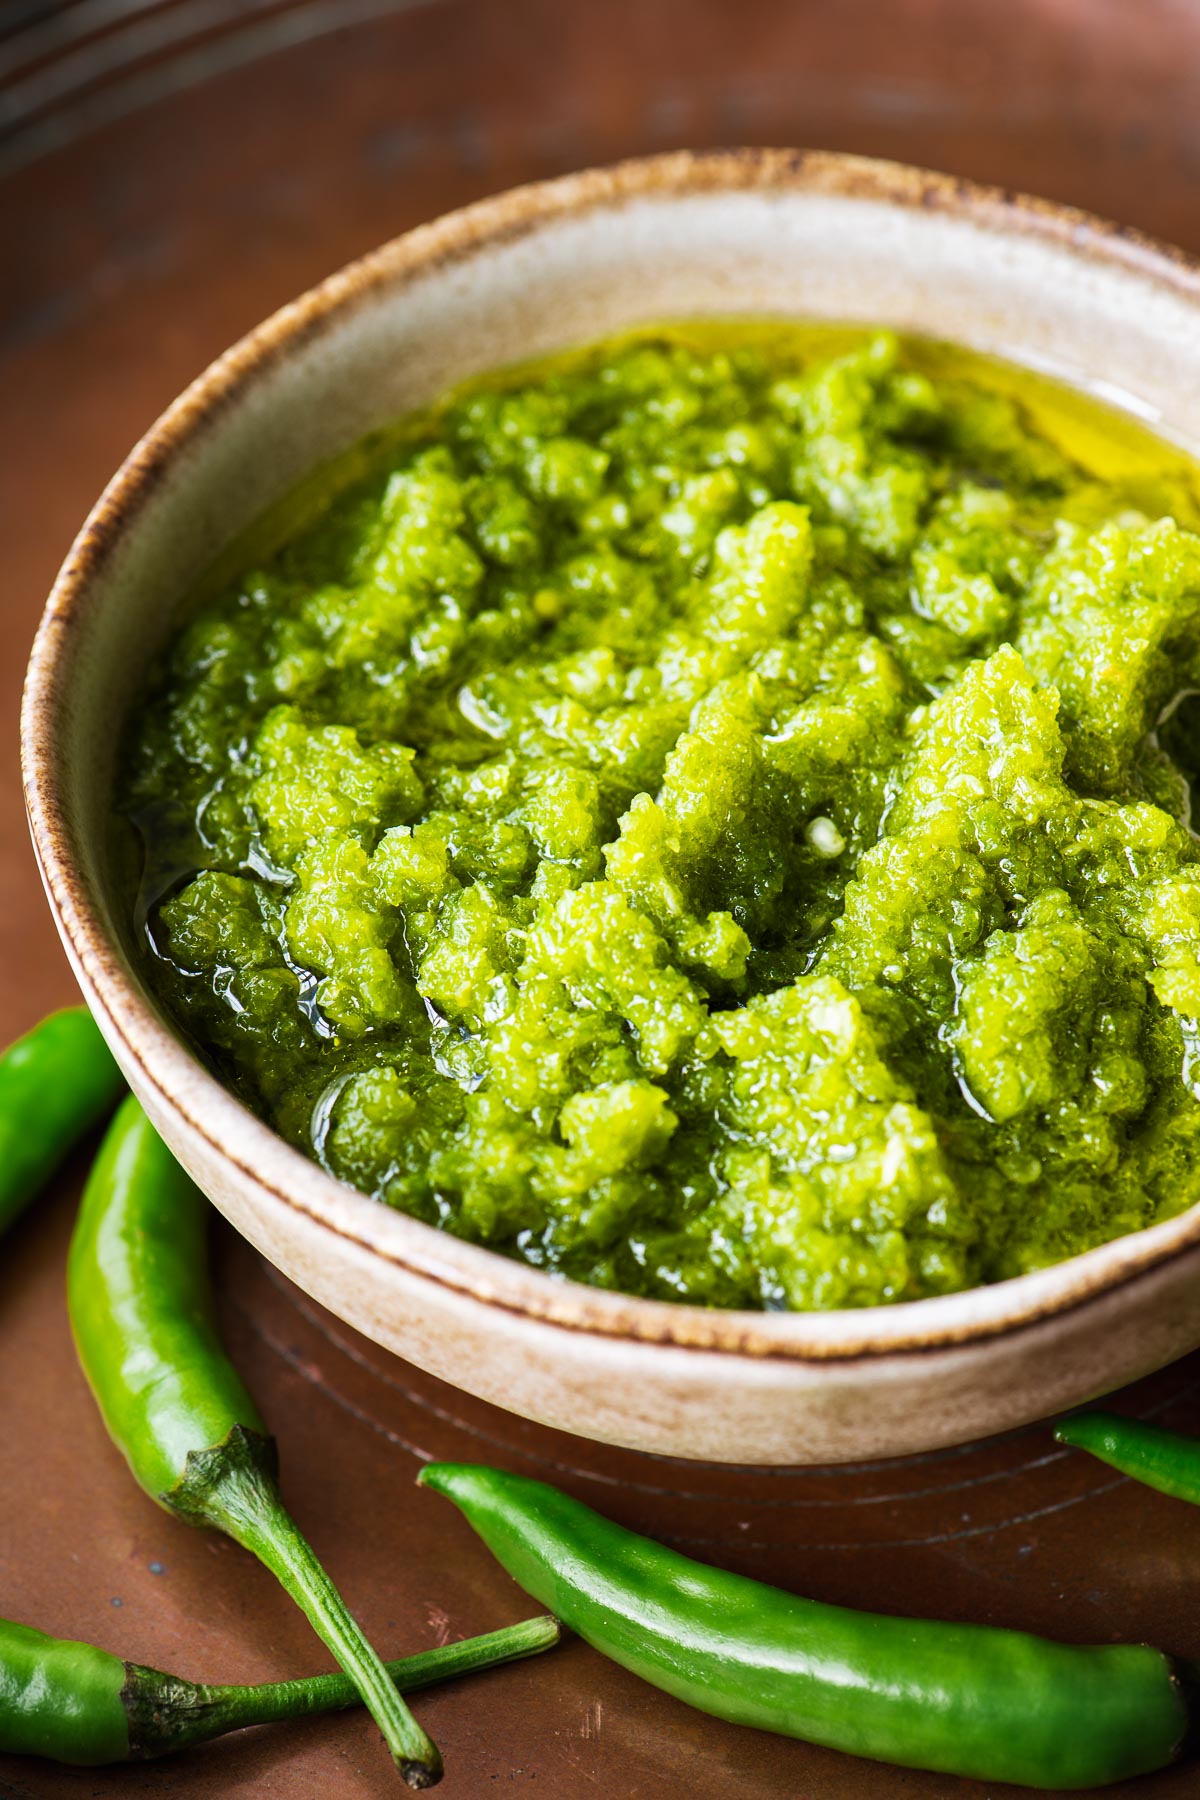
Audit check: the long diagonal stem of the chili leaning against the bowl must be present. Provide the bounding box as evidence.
[203,1462,441,1787]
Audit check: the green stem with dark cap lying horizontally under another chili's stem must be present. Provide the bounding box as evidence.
[122,1618,561,1757]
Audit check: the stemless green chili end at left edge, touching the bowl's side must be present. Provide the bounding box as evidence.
[0,1006,121,1233]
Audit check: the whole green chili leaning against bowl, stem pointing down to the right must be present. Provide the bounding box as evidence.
[67,1098,441,1787]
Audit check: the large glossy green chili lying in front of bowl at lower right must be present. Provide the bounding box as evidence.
[419,1463,1193,1791]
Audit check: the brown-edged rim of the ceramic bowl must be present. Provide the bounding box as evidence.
[22,149,1200,1363]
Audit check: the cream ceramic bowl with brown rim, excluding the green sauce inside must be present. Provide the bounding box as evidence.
[22,151,1200,1463]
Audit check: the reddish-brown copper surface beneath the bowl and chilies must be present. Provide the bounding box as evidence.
[0,0,1200,1800]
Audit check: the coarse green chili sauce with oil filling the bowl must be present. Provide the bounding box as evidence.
[119,324,1200,1309]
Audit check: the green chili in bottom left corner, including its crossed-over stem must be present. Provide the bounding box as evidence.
[0,1618,561,1768]
